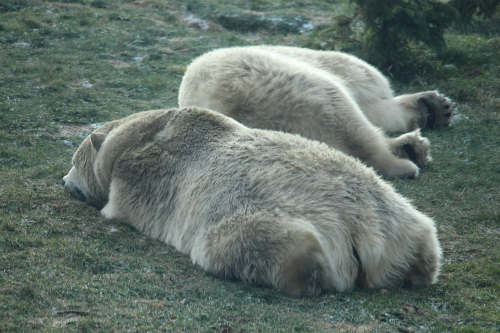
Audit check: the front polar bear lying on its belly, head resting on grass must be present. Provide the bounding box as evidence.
[62,107,441,297]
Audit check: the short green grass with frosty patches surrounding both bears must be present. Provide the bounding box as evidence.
[0,0,500,332]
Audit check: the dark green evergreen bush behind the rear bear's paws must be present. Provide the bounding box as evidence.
[352,0,456,69]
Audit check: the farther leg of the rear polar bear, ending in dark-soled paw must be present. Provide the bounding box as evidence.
[250,45,456,133]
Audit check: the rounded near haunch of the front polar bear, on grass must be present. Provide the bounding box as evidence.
[191,213,336,297]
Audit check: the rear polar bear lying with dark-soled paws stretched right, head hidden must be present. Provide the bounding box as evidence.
[179,46,455,178]
